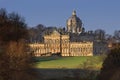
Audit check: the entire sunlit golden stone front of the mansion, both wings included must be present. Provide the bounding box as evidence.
[30,31,93,56]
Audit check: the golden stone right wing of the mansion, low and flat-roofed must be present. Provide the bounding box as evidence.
[70,42,93,56]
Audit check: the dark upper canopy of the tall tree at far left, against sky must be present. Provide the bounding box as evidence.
[0,8,27,42]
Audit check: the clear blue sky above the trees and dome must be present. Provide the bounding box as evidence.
[0,0,120,34]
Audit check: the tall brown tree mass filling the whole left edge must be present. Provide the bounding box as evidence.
[0,9,35,80]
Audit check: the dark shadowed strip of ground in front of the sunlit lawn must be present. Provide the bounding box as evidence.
[32,68,99,80]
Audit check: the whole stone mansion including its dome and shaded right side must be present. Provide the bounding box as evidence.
[30,11,108,56]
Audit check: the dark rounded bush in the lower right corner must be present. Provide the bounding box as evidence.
[99,45,120,80]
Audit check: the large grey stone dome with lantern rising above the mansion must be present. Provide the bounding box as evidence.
[67,11,82,33]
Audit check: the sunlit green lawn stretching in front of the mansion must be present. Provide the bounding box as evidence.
[34,56,104,69]
